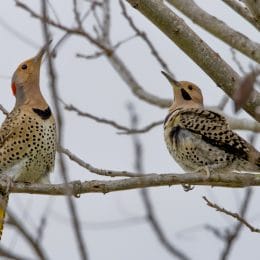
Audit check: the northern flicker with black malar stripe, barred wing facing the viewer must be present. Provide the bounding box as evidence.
[162,72,260,176]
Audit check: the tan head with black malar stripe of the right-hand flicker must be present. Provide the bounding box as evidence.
[162,71,203,109]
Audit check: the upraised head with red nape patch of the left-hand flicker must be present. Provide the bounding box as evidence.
[12,42,50,105]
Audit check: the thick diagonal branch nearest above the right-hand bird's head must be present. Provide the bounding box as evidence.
[127,0,260,121]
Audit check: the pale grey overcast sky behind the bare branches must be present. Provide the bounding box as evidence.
[0,0,260,260]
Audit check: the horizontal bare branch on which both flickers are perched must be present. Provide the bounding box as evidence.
[0,171,260,196]
